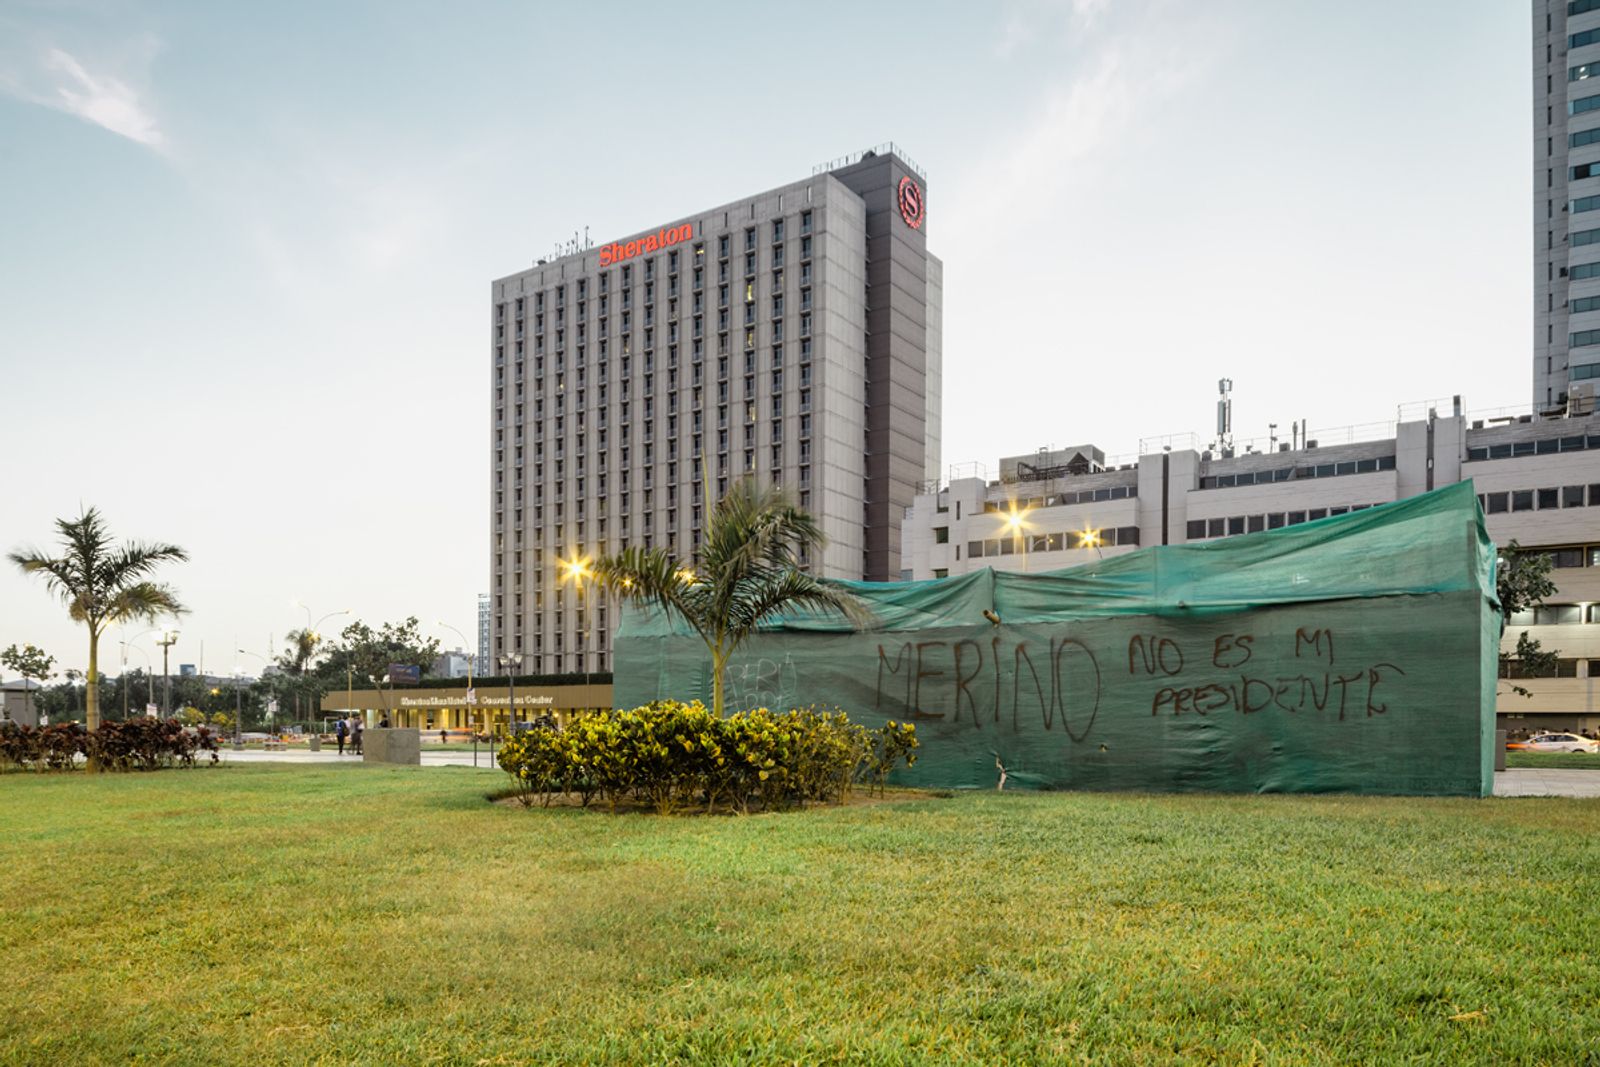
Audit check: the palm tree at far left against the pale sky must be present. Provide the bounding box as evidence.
[6,507,189,729]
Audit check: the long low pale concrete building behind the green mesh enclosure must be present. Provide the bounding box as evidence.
[904,405,1600,729]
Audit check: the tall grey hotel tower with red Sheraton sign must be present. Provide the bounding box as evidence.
[490,146,942,673]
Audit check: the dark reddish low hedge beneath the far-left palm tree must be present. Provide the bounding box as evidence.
[0,718,218,771]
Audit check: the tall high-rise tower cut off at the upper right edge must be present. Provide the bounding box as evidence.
[1533,0,1600,414]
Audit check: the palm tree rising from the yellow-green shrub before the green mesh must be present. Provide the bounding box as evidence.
[594,480,872,715]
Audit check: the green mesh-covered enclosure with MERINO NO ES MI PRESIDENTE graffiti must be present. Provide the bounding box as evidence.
[614,483,1499,795]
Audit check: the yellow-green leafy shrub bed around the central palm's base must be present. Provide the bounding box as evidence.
[499,701,917,814]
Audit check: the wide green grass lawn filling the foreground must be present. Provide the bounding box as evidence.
[0,765,1600,1067]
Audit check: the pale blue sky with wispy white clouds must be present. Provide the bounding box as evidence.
[0,0,1533,673]
